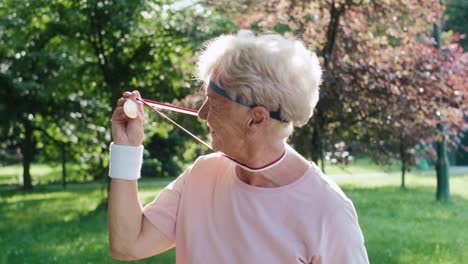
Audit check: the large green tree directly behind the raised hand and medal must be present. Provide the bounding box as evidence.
[71,1,236,175]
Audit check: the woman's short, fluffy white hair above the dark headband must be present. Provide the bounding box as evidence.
[196,30,322,129]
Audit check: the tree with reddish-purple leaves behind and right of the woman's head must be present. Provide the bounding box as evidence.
[209,0,467,192]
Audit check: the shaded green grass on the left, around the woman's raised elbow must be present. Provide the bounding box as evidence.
[0,187,175,263]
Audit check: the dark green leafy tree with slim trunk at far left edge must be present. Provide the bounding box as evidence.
[0,1,82,190]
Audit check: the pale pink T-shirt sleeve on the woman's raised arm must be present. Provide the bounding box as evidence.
[143,167,191,241]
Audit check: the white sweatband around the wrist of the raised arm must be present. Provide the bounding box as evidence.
[109,143,143,180]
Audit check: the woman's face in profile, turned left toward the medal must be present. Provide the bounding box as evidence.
[198,87,249,155]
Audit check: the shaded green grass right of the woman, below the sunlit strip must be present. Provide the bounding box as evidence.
[343,187,468,263]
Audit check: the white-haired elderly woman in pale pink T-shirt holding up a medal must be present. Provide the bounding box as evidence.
[109,31,368,264]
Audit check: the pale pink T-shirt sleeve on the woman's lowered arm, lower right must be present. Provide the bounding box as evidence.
[322,200,369,264]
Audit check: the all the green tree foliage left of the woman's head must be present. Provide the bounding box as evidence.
[0,0,234,185]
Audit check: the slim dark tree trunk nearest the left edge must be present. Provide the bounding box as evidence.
[21,122,36,190]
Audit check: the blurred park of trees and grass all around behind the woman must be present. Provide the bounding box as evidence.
[0,0,468,263]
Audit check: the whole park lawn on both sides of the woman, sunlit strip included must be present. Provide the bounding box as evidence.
[0,162,468,263]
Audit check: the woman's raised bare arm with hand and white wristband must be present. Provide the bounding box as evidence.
[108,91,174,260]
